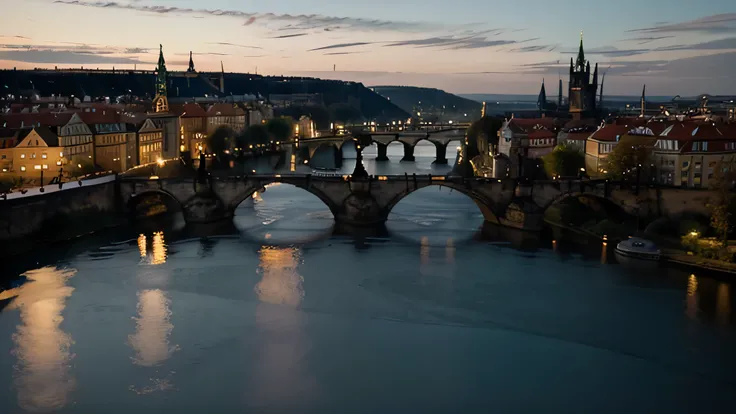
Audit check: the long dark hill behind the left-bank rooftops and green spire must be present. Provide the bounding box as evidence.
[0,69,410,122]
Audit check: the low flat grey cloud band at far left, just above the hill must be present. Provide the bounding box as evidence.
[0,50,148,64]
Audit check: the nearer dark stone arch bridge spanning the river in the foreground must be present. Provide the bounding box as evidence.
[118,175,705,230]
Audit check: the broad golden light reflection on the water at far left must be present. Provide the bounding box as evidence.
[7,267,76,411]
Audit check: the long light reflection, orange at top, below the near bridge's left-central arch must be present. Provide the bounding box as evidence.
[252,246,315,411]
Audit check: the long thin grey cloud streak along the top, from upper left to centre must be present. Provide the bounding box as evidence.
[53,0,442,32]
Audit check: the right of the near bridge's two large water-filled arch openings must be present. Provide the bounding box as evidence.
[386,185,488,245]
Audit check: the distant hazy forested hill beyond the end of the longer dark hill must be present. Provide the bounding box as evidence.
[369,86,482,119]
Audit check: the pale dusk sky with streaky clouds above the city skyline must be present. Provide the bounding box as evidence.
[0,0,736,96]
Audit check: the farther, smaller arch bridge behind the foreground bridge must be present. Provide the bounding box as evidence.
[295,126,467,164]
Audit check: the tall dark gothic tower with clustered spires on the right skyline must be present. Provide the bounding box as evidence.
[568,32,598,119]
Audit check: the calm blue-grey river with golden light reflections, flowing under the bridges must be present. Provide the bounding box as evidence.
[0,142,736,414]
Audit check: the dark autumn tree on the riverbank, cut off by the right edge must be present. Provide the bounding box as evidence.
[707,159,736,247]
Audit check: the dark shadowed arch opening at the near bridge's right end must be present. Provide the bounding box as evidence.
[544,194,639,240]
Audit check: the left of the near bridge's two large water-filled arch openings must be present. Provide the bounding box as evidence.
[233,182,335,245]
